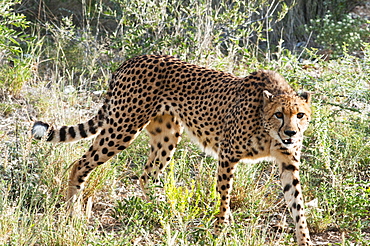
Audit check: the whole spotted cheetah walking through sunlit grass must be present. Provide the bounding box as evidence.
[32,55,312,245]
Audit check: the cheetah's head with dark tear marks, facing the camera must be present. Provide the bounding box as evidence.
[263,90,311,148]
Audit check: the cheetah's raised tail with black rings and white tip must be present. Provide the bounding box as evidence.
[32,114,104,143]
